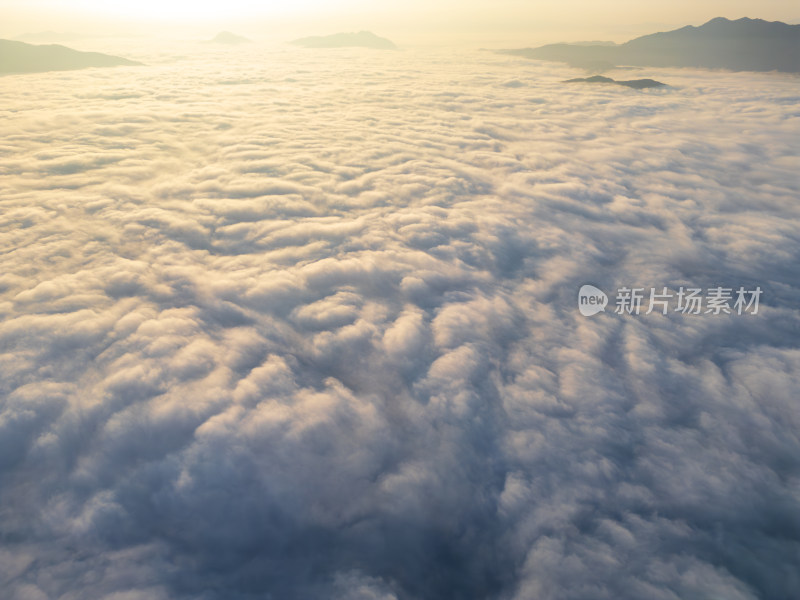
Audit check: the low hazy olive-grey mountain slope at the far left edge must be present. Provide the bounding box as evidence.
[0,40,141,73]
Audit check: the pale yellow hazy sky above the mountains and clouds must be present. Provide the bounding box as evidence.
[0,0,800,40]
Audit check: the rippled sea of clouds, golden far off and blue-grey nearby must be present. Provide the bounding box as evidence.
[0,45,800,600]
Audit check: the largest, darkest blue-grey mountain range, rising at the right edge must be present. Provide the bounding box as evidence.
[501,17,800,73]
